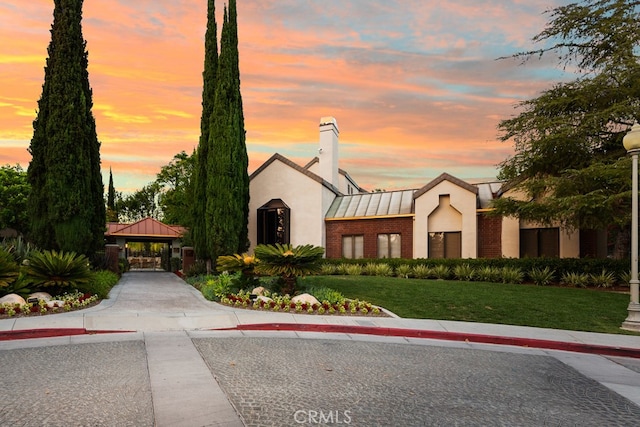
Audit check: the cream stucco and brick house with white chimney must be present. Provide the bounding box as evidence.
[249,117,606,258]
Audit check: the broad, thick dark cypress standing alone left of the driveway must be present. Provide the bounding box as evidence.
[27,0,105,254]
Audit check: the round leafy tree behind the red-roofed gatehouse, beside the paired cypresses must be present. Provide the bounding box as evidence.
[155,151,195,227]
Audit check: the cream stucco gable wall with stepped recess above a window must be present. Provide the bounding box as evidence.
[413,180,478,258]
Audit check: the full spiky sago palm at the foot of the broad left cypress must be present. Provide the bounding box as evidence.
[23,251,92,291]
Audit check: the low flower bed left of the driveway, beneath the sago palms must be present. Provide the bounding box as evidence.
[0,292,99,319]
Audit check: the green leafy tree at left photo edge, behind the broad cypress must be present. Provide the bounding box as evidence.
[0,165,31,233]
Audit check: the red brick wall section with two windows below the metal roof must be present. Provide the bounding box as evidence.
[325,217,413,258]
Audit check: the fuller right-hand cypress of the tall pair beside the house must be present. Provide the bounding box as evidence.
[210,0,249,259]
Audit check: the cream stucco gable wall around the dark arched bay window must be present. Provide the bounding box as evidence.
[249,160,333,251]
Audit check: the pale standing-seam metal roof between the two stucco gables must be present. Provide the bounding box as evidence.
[325,190,415,219]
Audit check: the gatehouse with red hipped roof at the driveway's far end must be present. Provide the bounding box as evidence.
[105,218,186,270]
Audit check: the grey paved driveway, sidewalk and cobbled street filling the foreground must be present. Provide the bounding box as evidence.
[0,272,640,426]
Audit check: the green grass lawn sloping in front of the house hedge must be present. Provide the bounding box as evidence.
[299,276,629,333]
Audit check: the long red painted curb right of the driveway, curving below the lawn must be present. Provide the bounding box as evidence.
[217,323,640,359]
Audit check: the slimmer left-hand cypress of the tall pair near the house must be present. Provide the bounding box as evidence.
[191,0,218,260]
